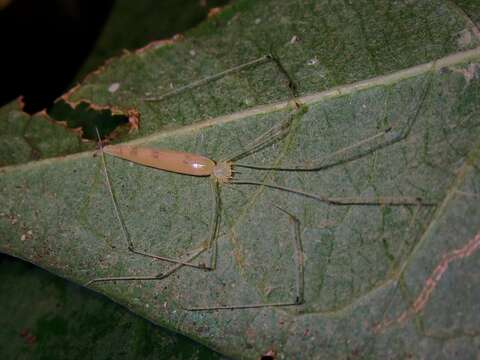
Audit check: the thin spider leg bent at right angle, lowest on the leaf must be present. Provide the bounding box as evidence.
[184,205,305,311]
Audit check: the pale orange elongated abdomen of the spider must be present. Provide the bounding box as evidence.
[103,145,215,176]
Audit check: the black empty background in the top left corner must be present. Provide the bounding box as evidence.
[0,0,114,113]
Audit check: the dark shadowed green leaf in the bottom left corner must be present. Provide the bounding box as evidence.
[0,256,227,360]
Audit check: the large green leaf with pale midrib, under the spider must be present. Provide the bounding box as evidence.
[0,1,480,359]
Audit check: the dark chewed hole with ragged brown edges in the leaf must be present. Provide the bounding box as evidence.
[48,100,129,141]
